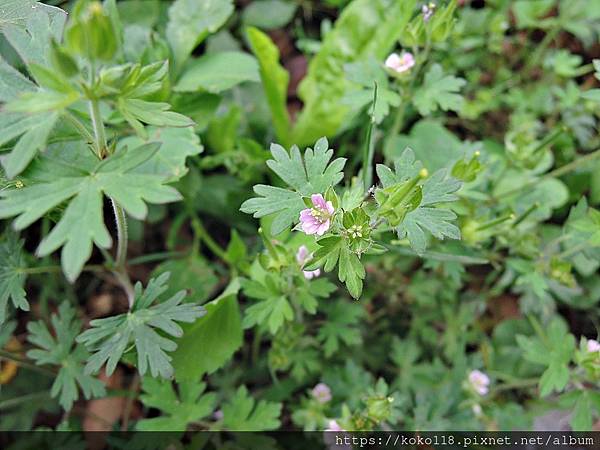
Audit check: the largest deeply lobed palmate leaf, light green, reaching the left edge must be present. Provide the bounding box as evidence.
[0,143,180,281]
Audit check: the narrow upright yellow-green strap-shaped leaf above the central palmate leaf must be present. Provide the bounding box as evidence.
[246,27,291,146]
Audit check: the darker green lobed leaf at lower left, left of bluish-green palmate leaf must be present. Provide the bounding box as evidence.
[27,302,105,410]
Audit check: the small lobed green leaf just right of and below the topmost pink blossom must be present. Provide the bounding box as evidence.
[412,64,466,116]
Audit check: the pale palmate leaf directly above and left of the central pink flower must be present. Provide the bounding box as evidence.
[240,138,346,235]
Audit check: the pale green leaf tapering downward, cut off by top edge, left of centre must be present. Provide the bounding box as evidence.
[166,0,234,67]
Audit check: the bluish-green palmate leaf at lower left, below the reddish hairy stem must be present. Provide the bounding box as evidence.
[77,272,206,378]
